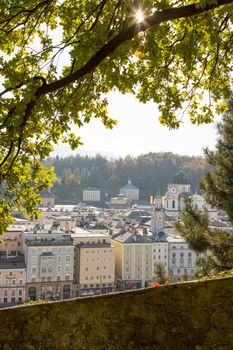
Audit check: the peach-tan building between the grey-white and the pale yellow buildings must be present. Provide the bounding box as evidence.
[72,228,115,296]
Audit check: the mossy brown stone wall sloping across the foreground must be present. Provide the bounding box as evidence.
[0,278,233,350]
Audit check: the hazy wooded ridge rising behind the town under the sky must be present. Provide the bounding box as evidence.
[46,152,209,203]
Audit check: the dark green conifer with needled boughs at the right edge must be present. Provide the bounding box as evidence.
[176,102,233,275]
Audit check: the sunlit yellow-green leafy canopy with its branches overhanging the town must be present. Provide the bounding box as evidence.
[0,0,233,230]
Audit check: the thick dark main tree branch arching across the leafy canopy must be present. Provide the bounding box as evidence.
[0,0,233,170]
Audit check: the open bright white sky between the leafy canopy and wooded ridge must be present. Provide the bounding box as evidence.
[53,93,219,157]
